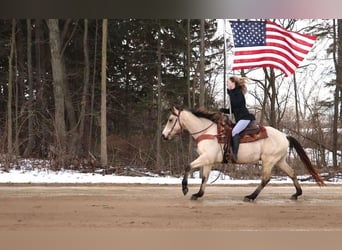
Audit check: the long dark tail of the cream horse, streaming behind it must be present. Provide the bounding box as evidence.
[286,136,325,186]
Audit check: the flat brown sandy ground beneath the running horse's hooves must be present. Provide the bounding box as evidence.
[0,185,342,249]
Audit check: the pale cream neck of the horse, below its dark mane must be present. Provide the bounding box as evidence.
[180,111,212,138]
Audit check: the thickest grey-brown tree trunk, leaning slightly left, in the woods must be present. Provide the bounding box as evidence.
[47,19,66,164]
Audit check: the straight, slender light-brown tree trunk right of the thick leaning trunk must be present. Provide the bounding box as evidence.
[101,19,108,167]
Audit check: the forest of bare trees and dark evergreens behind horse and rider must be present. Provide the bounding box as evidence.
[0,19,342,178]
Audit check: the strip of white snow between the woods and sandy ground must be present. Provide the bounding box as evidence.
[0,169,342,185]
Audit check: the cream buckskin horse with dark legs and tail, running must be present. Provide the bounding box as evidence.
[162,107,325,202]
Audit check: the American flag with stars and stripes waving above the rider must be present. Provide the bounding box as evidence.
[230,21,316,76]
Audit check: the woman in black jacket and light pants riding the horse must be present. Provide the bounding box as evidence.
[220,76,255,163]
